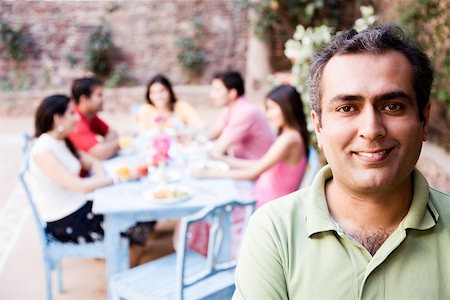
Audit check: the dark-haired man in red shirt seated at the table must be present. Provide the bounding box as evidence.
[69,77,119,159]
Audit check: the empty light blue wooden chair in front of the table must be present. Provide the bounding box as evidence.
[110,201,255,300]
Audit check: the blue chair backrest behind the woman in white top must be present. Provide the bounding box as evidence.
[19,133,49,247]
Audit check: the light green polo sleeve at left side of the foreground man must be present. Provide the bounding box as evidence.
[233,210,288,300]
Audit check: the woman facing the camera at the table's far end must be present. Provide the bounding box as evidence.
[136,74,203,133]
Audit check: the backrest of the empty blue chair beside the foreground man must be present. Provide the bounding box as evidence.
[177,200,255,299]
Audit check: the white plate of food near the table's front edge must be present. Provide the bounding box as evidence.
[143,186,192,205]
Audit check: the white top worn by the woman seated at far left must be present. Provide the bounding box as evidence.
[29,133,86,222]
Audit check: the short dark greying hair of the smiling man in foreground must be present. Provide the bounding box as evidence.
[308,25,433,121]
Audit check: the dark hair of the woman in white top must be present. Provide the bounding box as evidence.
[34,95,80,158]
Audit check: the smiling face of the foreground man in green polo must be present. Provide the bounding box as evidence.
[312,51,429,193]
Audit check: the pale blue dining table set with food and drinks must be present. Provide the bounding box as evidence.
[92,155,253,298]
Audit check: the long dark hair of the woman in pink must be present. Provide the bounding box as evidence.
[266,85,309,152]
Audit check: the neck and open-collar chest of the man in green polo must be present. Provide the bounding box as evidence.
[325,179,413,255]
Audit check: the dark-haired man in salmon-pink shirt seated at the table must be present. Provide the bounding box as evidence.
[210,71,274,159]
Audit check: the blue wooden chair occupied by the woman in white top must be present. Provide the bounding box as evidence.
[19,134,128,300]
